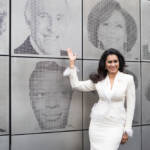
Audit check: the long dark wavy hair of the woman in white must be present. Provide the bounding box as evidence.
[89,48,126,83]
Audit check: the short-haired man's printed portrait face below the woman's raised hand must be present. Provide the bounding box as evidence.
[29,61,72,130]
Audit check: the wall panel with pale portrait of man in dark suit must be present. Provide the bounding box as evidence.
[12,0,82,57]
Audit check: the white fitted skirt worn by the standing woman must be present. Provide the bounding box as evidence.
[89,117,124,150]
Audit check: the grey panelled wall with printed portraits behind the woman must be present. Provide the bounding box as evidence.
[0,0,150,150]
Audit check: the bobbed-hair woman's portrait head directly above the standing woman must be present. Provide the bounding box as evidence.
[88,0,137,55]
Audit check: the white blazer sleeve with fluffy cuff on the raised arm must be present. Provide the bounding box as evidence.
[64,67,96,92]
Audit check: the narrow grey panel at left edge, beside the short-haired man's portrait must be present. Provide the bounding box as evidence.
[0,56,9,135]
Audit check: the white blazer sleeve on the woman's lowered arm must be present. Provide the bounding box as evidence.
[124,76,135,136]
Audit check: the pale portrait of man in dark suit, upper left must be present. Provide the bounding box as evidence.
[14,0,69,56]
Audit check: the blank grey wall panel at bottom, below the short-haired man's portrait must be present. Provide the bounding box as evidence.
[12,132,82,150]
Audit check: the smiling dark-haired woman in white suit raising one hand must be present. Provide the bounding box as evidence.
[64,49,135,150]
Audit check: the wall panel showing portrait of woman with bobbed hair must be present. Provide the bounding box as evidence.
[83,0,140,60]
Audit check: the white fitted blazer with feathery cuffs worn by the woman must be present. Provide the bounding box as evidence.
[64,67,135,136]
